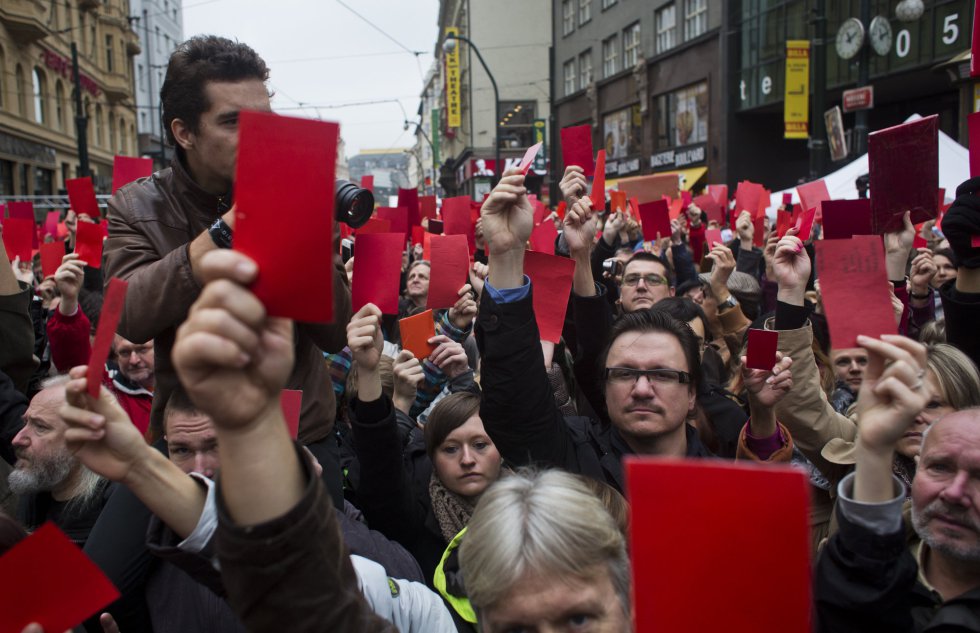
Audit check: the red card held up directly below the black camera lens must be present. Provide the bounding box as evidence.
[351,233,405,314]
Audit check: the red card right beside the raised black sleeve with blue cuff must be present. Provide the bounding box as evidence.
[524,251,575,344]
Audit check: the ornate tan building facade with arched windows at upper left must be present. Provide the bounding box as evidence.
[0,0,140,196]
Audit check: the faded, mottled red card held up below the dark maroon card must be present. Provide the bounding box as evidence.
[816,235,897,349]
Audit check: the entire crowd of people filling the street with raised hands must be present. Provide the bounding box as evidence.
[0,36,980,633]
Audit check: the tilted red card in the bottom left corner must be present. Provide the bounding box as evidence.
[0,521,119,633]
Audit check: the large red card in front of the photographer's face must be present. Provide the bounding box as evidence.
[234,111,340,323]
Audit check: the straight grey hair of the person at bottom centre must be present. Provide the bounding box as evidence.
[459,469,630,616]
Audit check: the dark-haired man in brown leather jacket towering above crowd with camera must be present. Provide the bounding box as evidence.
[105,36,351,504]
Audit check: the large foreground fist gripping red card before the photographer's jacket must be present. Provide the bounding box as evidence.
[173,249,294,429]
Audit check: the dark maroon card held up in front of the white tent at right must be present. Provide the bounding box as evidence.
[868,115,939,234]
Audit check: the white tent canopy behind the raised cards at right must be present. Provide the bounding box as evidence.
[769,114,970,215]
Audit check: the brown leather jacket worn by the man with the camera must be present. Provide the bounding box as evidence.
[104,159,351,444]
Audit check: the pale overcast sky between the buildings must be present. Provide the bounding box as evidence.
[184,0,439,157]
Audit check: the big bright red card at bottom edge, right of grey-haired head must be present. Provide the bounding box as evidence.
[624,457,811,633]
